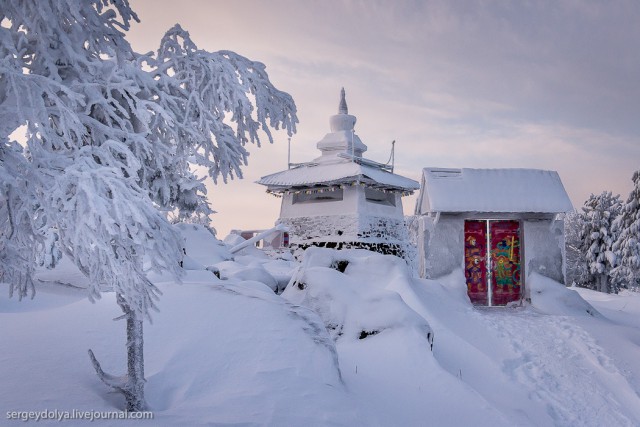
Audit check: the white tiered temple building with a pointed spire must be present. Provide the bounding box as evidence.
[258,89,419,255]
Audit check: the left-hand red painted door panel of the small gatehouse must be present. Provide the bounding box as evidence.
[464,221,489,305]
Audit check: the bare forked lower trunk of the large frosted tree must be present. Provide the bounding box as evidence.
[89,294,147,412]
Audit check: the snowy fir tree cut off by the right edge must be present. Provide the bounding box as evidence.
[613,170,640,289]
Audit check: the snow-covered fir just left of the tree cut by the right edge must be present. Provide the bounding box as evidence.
[579,191,621,293]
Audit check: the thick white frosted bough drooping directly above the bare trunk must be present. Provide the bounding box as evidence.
[45,148,182,315]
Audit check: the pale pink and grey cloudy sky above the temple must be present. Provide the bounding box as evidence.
[128,0,640,238]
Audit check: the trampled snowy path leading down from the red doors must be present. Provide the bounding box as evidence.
[478,309,640,426]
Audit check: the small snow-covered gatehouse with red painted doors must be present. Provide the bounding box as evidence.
[414,168,573,306]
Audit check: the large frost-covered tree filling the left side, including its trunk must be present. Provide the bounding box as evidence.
[0,0,297,410]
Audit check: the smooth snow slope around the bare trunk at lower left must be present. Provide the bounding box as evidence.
[0,271,367,426]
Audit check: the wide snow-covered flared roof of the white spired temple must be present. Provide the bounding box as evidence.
[257,161,420,191]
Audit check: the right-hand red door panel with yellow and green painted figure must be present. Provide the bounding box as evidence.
[489,221,521,305]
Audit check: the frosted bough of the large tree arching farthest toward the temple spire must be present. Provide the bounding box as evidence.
[156,25,298,182]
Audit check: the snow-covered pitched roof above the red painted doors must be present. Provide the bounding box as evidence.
[416,168,573,214]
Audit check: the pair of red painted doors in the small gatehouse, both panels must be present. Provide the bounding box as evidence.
[464,220,522,305]
